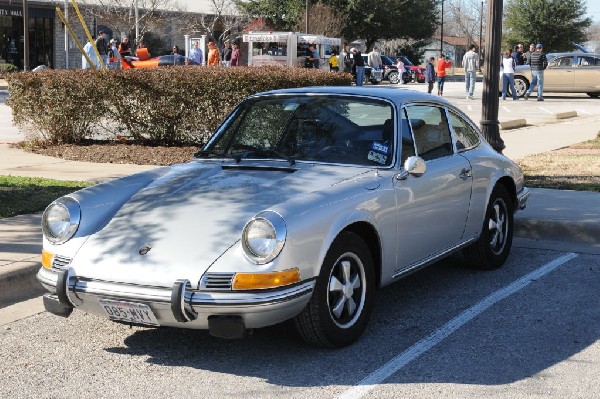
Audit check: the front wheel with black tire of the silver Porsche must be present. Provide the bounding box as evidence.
[294,232,375,348]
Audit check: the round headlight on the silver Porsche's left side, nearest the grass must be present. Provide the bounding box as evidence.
[42,197,81,244]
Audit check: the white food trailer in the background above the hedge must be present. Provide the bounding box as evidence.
[243,32,342,69]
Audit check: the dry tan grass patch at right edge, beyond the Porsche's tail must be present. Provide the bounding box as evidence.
[519,133,600,192]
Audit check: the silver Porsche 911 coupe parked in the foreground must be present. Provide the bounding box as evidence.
[37,87,529,347]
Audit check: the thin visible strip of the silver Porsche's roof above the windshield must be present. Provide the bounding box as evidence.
[256,86,450,105]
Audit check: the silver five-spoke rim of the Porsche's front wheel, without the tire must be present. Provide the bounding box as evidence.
[327,252,367,328]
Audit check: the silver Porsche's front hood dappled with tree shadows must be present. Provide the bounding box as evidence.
[72,161,368,286]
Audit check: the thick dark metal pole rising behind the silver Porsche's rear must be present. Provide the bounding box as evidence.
[480,0,506,153]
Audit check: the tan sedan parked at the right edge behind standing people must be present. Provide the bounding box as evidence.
[500,53,600,98]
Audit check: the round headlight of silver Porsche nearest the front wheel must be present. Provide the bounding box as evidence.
[242,211,286,264]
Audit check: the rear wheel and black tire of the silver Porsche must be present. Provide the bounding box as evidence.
[463,185,514,270]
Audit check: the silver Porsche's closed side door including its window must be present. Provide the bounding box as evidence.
[394,105,472,274]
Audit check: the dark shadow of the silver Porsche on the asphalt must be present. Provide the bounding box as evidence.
[105,248,599,387]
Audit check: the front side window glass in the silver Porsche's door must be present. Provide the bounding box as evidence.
[406,105,453,161]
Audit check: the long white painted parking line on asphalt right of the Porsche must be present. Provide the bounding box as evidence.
[340,252,578,399]
